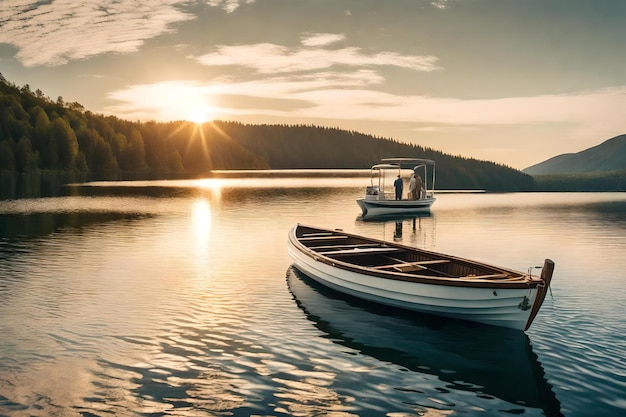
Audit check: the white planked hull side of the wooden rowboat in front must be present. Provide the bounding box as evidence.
[288,226,543,330]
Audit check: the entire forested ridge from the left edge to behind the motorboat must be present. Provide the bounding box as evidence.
[0,74,533,191]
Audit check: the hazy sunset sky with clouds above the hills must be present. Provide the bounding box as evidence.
[0,0,626,169]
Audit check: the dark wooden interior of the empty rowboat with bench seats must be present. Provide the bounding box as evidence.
[298,231,525,281]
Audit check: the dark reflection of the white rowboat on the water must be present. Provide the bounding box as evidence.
[287,267,562,416]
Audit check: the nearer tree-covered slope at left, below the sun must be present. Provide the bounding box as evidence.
[0,81,268,179]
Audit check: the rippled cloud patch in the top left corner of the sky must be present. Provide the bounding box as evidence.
[0,0,194,67]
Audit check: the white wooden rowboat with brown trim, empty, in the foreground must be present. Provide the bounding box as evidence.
[287,224,554,330]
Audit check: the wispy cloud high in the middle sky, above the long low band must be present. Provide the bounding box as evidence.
[196,33,439,74]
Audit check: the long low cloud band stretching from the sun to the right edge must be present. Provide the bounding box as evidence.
[106,74,626,137]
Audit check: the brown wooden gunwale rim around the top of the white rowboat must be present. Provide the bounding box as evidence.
[289,223,544,289]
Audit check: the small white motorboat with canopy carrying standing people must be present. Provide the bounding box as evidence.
[357,158,436,217]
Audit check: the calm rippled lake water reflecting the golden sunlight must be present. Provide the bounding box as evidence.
[0,171,626,417]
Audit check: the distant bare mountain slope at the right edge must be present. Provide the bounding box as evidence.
[522,134,626,175]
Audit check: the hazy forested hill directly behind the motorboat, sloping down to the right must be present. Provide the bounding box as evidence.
[208,122,533,191]
